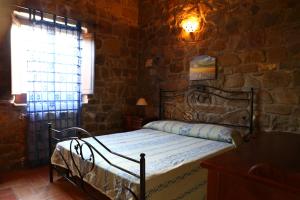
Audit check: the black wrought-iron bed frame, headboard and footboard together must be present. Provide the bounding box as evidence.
[48,85,253,200]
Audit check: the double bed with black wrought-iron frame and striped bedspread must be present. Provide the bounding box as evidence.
[49,85,253,200]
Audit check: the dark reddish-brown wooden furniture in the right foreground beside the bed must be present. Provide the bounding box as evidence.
[201,133,300,200]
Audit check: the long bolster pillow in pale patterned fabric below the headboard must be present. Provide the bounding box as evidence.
[143,120,242,145]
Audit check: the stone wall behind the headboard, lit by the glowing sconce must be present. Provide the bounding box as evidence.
[139,0,300,133]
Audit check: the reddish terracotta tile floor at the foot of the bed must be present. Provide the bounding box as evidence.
[0,167,107,200]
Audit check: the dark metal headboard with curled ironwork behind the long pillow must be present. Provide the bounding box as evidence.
[159,84,254,137]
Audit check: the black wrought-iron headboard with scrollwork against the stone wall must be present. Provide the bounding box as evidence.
[159,84,254,135]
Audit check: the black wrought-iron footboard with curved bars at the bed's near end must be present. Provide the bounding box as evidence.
[48,123,146,200]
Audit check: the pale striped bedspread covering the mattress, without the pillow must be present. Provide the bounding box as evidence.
[51,129,234,200]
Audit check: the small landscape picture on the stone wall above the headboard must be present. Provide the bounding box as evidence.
[190,55,217,81]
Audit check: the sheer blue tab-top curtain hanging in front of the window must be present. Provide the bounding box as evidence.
[22,17,81,166]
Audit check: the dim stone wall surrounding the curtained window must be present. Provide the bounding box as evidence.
[0,0,138,169]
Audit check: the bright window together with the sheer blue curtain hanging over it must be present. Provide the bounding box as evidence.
[11,10,94,165]
